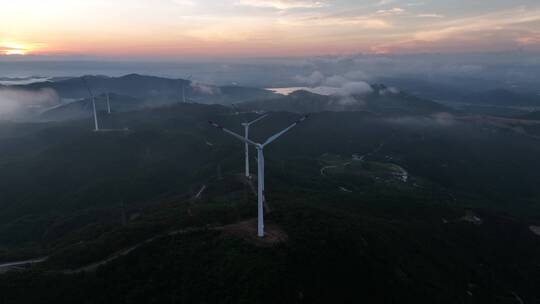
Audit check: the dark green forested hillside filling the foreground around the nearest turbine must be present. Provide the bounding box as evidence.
[0,104,540,303]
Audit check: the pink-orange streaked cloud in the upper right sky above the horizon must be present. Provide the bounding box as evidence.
[372,7,540,53]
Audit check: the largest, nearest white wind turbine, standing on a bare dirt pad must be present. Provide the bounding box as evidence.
[209,115,308,238]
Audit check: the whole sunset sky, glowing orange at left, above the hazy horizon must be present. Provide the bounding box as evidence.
[0,0,540,58]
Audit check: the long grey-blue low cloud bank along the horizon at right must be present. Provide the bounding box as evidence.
[296,51,540,86]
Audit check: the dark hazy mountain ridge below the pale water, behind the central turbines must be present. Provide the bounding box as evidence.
[242,85,453,114]
